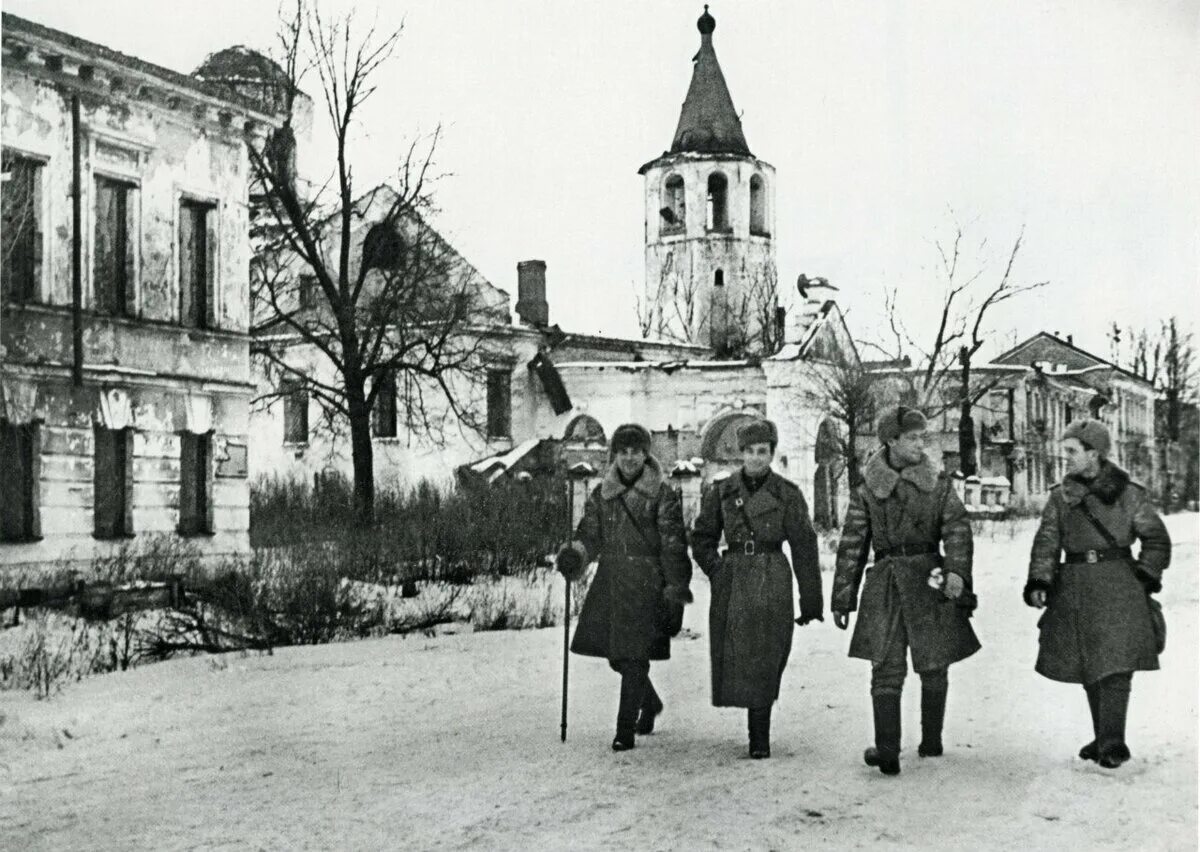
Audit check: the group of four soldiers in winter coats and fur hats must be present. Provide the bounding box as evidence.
[557,406,1171,775]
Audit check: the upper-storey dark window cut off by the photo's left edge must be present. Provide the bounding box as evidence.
[0,152,42,302]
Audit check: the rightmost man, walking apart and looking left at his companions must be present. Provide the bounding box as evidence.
[1025,420,1171,769]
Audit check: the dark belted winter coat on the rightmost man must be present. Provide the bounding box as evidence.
[1025,462,1171,684]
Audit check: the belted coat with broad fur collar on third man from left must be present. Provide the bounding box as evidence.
[832,449,979,672]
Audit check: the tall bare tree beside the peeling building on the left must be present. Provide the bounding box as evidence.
[248,0,487,526]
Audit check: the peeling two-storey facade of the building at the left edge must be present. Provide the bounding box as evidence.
[0,14,277,566]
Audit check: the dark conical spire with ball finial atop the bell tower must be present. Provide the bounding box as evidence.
[671,5,750,155]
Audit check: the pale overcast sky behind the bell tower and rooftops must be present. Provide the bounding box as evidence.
[11,0,1200,355]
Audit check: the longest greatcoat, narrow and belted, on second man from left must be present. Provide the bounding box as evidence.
[691,472,823,707]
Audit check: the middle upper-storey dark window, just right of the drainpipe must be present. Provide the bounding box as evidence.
[91,175,137,316]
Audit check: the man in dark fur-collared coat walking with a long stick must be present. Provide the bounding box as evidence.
[558,424,691,751]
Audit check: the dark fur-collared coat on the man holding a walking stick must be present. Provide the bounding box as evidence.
[571,458,691,661]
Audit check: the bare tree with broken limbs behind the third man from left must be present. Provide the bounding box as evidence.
[871,221,1049,476]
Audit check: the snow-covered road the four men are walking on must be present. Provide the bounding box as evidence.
[0,515,1200,850]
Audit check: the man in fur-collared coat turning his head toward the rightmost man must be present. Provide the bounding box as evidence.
[830,406,979,775]
